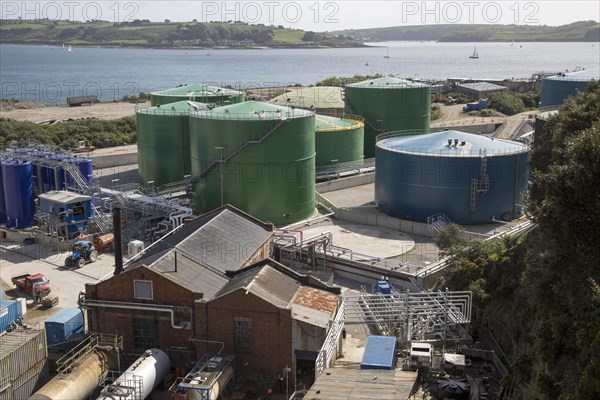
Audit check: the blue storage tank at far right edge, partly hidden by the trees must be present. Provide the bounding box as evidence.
[540,68,600,107]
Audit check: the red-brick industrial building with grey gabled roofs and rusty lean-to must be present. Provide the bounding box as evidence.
[82,206,339,383]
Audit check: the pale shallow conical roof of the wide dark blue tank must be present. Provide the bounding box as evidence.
[377,130,529,157]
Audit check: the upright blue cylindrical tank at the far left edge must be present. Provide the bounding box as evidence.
[2,160,35,229]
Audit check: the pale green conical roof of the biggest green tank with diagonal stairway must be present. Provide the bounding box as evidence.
[190,101,314,121]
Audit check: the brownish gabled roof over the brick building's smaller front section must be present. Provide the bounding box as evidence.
[216,265,300,308]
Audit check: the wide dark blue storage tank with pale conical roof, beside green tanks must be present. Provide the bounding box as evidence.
[375,131,530,224]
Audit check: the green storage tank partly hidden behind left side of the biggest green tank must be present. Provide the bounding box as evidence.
[136,101,207,186]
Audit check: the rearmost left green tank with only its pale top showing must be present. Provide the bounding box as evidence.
[150,83,244,106]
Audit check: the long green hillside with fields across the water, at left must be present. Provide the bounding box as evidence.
[0,20,362,48]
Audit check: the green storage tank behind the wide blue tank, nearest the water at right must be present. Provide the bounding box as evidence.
[344,76,431,158]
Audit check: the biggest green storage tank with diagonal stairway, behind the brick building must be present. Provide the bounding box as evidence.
[188,101,315,226]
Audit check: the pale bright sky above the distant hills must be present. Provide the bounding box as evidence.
[0,0,600,32]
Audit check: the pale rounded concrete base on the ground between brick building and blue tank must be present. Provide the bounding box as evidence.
[302,220,415,260]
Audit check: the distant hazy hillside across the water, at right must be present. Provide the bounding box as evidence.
[331,21,600,42]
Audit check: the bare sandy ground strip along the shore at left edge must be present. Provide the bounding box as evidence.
[0,102,150,122]
